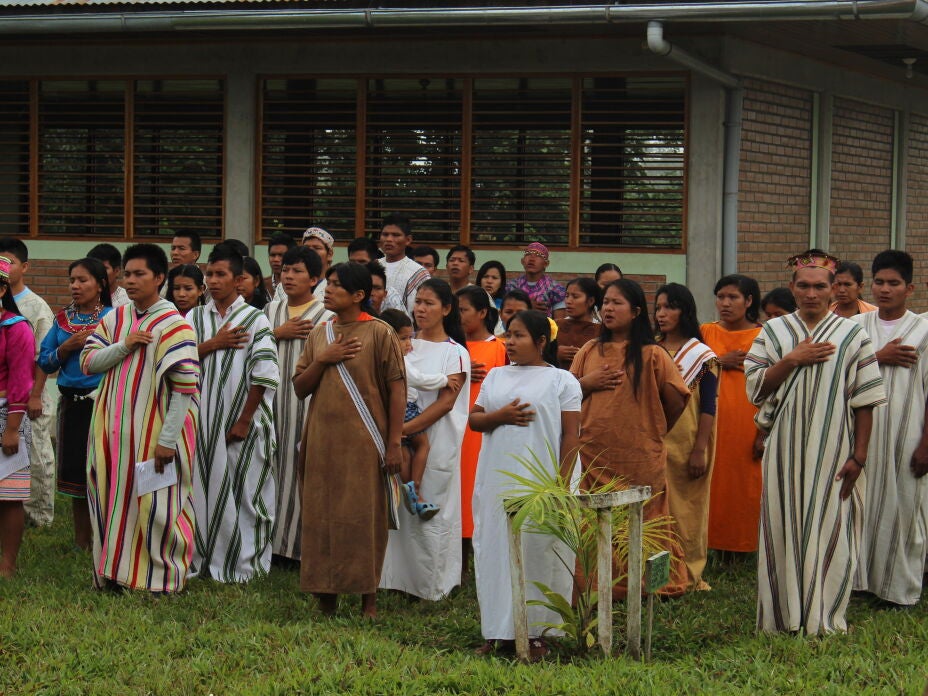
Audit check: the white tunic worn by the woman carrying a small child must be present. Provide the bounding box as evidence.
[380,339,470,600]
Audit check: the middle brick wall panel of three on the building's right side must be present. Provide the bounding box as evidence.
[828,98,893,270]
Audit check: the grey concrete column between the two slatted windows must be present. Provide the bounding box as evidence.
[223,70,258,248]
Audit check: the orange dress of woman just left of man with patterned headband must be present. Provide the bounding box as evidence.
[701,323,761,551]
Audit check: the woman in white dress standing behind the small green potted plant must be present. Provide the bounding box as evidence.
[470,310,583,658]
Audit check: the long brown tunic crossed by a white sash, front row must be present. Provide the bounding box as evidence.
[296,319,405,594]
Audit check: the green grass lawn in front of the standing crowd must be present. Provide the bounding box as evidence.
[0,503,928,696]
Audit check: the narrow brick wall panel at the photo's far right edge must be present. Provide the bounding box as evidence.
[905,114,928,312]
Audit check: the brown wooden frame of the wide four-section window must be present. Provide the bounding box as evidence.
[254,71,691,255]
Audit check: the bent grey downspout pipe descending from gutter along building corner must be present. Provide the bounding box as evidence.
[647,21,744,275]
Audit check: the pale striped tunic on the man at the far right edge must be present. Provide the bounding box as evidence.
[853,312,928,604]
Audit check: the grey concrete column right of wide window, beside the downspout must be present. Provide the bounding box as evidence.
[686,73,725,321]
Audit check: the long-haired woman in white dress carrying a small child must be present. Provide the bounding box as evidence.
[380,278,470,600]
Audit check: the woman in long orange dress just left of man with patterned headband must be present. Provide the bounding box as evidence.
[700,274,764,552]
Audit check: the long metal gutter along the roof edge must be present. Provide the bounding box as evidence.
[0,0,928,34]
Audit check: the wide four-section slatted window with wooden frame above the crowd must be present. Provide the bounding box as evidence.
[258,74,687,250]
